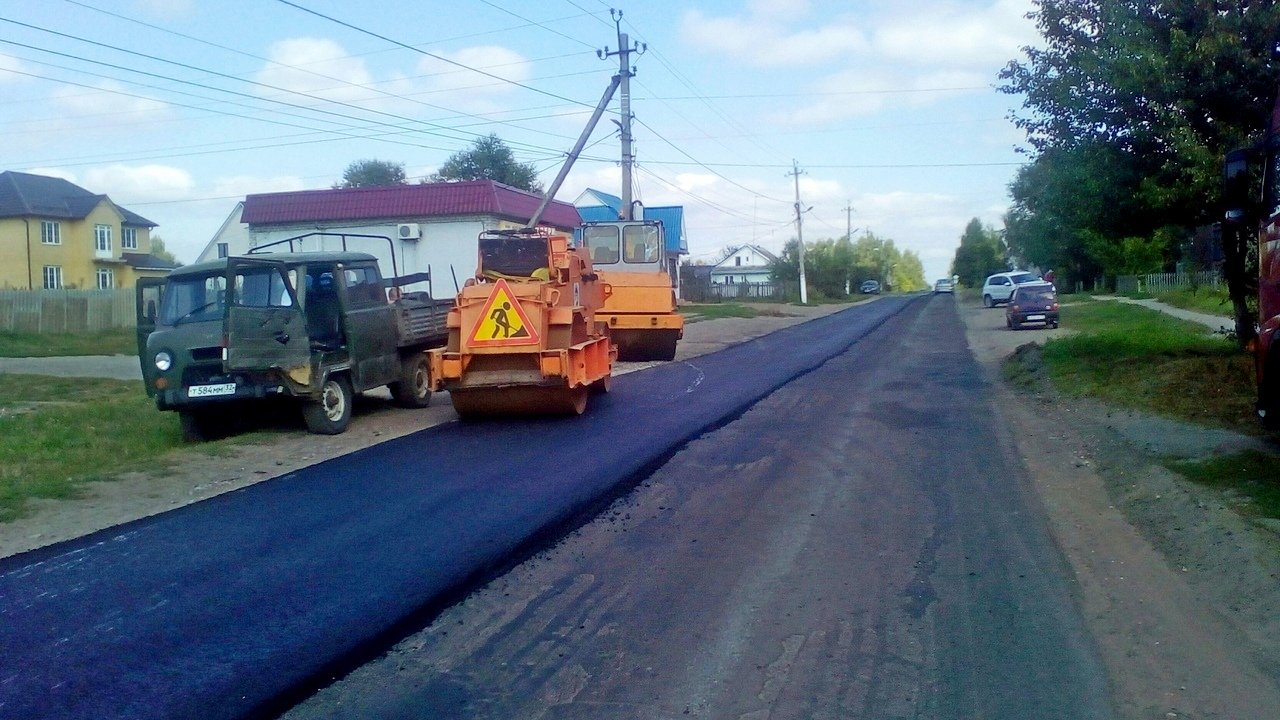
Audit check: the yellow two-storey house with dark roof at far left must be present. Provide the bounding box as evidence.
[0,172,177,290]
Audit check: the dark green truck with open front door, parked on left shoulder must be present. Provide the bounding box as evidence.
[137,241,453,441]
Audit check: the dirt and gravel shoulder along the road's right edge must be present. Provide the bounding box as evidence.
[957,299,1280,720]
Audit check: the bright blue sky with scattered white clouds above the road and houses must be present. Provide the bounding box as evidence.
[0,0,1038,281]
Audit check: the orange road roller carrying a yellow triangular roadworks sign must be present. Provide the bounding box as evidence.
[429,228,617,420]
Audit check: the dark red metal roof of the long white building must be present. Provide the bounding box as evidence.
[241,179,582,231]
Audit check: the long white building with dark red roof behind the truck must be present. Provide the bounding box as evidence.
[200,179,582,296]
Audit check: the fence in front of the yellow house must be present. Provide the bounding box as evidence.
[0,288,137,333]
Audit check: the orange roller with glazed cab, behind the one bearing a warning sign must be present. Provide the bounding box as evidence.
[582,213,685,360]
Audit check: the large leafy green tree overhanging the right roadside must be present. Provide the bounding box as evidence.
[1001,0,1280,337]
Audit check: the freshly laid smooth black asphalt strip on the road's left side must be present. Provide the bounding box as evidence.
[0,297,918,719]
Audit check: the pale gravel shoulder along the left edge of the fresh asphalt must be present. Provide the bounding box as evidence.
[0,299,849,557]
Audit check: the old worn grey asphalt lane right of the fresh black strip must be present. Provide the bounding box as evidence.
[288,297,1112,720]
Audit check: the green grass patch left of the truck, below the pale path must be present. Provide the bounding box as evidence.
[0,373,257,521]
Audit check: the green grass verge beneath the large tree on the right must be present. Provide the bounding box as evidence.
[1005,302,1257,433]
